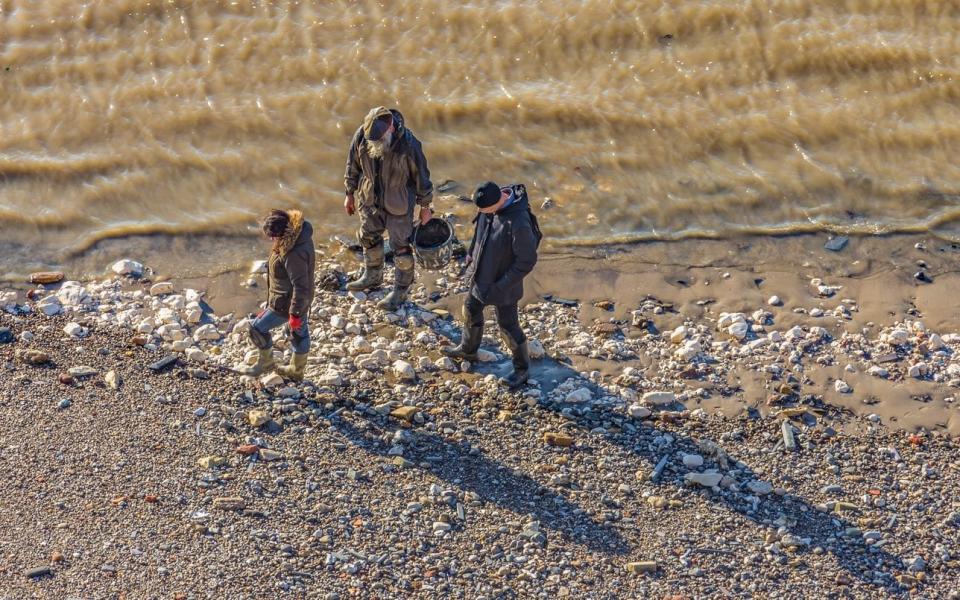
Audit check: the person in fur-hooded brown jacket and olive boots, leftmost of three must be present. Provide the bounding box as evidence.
[242,209,317,381]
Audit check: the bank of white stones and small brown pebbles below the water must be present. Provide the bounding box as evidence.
[0,255,960,599]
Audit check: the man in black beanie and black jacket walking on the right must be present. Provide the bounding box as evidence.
[443,181,540,389]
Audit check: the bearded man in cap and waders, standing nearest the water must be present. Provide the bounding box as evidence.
[343,106,433,311]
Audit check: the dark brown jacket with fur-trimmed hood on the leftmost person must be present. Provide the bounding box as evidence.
[267,210,317,319]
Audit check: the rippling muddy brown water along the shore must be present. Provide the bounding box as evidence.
[0,0,960,276]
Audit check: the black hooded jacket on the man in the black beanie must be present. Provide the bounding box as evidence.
[465,185,540,306]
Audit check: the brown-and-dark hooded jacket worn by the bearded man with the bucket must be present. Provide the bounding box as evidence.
[344,106,433,216]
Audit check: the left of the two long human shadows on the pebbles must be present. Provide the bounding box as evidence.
[331,418,630,555]
